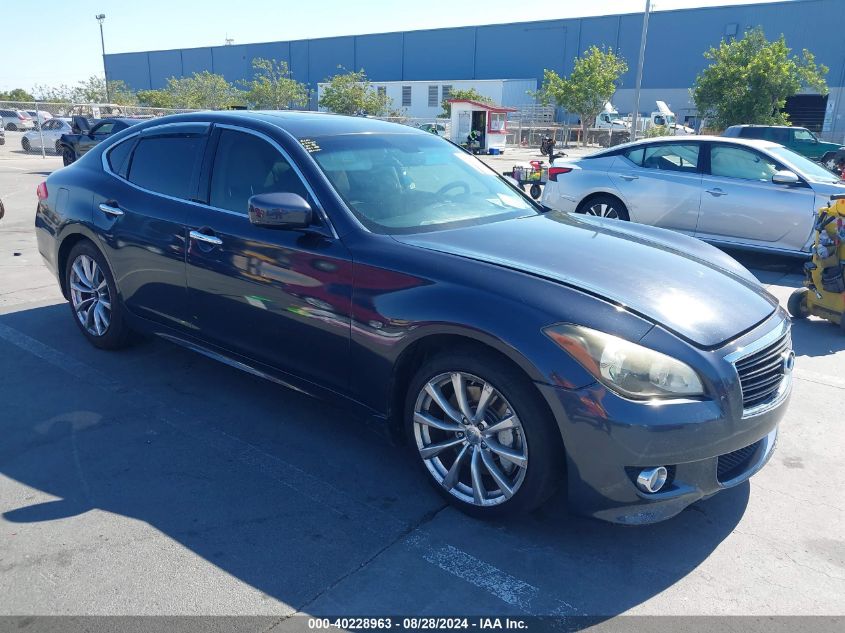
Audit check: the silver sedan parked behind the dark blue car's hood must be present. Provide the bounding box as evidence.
[542,136,845,255]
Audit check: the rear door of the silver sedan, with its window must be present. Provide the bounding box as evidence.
[610,141,701,234]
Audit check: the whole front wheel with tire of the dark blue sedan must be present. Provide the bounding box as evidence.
[405,350,564,519]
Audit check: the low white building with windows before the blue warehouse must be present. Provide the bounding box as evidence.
[317,79,537,119]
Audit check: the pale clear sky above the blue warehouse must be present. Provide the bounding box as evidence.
[0,0,784,90]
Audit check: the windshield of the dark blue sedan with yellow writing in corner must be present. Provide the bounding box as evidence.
[300,133,539,233]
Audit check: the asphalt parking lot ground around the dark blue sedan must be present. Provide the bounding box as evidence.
[0,132,845,620]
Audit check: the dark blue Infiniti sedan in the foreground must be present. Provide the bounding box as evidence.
[35,112,794,523]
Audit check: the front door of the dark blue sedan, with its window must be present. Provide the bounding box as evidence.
[187,128,352,391]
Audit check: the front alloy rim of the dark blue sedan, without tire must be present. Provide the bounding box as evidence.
[413,372,528,507]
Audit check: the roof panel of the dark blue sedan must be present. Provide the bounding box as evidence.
[130,110,431,139]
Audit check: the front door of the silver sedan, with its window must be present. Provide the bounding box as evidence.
[696,143,815,250]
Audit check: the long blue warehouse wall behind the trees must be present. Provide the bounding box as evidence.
[106,0,845,96]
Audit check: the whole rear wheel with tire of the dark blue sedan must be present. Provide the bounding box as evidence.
[65,240,130,349]
